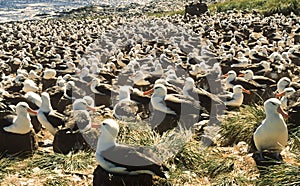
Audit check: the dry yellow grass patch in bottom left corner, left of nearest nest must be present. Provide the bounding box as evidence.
[0,151,96,185]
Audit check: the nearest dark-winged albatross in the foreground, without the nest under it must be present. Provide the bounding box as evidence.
[96,119,167,178]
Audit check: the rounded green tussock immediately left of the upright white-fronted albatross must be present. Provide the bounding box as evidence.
[220,106,265,146]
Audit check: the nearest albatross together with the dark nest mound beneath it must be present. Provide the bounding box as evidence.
[93,119,167,185]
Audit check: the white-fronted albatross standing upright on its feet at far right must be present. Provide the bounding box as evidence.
[253,98,288,159]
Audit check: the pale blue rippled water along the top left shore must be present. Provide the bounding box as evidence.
[0,0,148,22]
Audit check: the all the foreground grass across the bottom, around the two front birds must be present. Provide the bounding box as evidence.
[0,106,300,185]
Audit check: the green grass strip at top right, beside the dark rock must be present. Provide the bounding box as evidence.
[209,0,300,16]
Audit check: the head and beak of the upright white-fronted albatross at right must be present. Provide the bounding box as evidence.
[264,98,288,118]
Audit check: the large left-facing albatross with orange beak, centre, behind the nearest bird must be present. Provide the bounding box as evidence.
[144,83,207,134]
